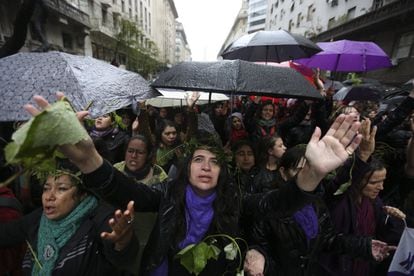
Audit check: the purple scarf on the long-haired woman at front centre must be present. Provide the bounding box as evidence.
[150,184,216,276]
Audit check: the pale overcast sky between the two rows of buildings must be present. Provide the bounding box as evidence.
[174,0,242,61]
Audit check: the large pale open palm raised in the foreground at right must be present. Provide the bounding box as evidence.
[297,114,361,191]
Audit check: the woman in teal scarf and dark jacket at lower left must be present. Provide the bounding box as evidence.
[0,161,139,275]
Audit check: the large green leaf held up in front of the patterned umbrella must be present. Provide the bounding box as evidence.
[5,101,88,181]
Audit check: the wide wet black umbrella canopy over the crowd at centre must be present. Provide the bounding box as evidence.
[151,60,321,99]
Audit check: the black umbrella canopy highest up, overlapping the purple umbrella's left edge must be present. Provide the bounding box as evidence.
[221,30,322,62]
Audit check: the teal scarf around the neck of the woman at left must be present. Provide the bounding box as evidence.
[32,196,98,275]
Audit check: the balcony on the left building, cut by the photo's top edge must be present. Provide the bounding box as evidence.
[44,0,90,27]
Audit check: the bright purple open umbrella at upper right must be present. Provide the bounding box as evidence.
[296,40,392,72]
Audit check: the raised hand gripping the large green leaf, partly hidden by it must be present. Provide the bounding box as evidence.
[24,92,103,173]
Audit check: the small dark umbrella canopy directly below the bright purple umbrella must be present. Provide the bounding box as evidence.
[333,85,382,102]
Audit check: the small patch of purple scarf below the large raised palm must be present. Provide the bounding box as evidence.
[293,204,319,242]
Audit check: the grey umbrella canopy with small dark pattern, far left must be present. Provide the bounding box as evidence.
[0,52,160,121]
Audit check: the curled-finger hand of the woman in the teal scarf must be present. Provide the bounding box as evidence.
[101,201,134,251]
